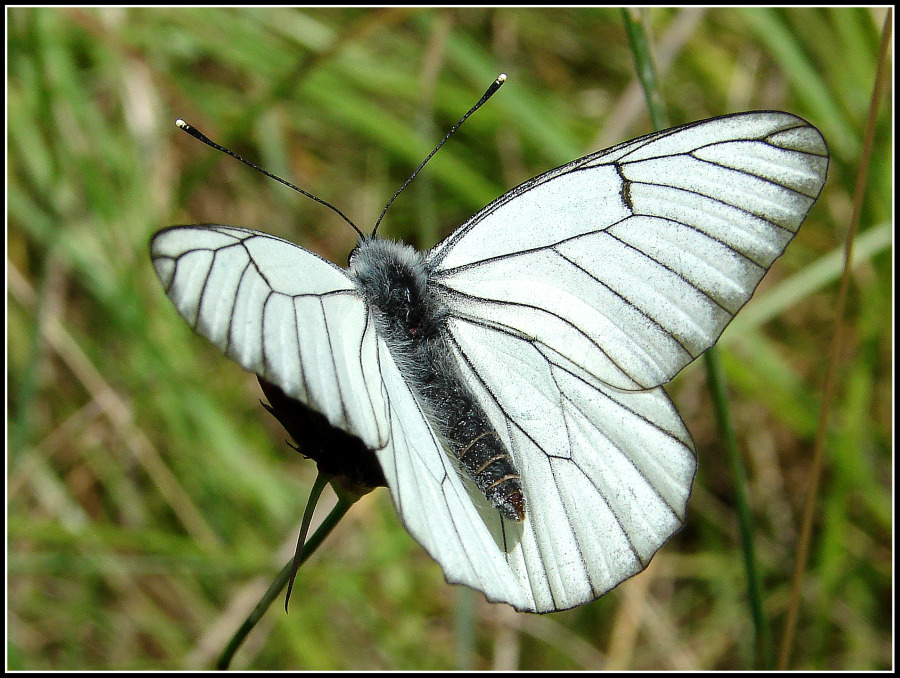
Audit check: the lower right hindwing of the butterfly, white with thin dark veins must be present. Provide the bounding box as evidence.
[450,320,695,612]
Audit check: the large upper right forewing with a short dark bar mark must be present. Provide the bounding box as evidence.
[429,111,828,390]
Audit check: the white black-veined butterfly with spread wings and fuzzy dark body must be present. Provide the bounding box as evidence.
[151,111,828,612]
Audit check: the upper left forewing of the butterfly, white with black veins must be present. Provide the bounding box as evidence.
[150,225,388,449]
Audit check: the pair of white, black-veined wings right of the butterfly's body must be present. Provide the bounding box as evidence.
[428,111,827,610]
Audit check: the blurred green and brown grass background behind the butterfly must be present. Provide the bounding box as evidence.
[7,8,893,670]
